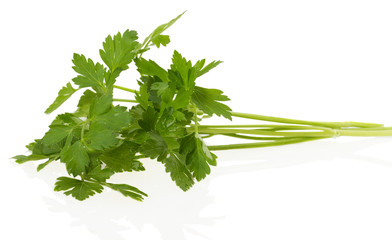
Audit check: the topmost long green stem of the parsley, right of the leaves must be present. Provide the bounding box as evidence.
[231,112,383,128]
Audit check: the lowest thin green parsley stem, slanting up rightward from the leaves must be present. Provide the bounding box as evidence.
[208,138,323,151]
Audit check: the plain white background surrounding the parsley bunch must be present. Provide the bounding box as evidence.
[0,0,392,240]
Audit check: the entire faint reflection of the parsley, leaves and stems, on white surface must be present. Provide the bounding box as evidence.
[18,138,392,240]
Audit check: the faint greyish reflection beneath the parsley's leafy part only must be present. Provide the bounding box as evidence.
[18,160,224,240]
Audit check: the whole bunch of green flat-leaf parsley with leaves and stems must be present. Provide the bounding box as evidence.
[14,14,392,201]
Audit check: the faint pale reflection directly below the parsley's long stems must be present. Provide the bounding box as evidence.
[214,137,392,176]
